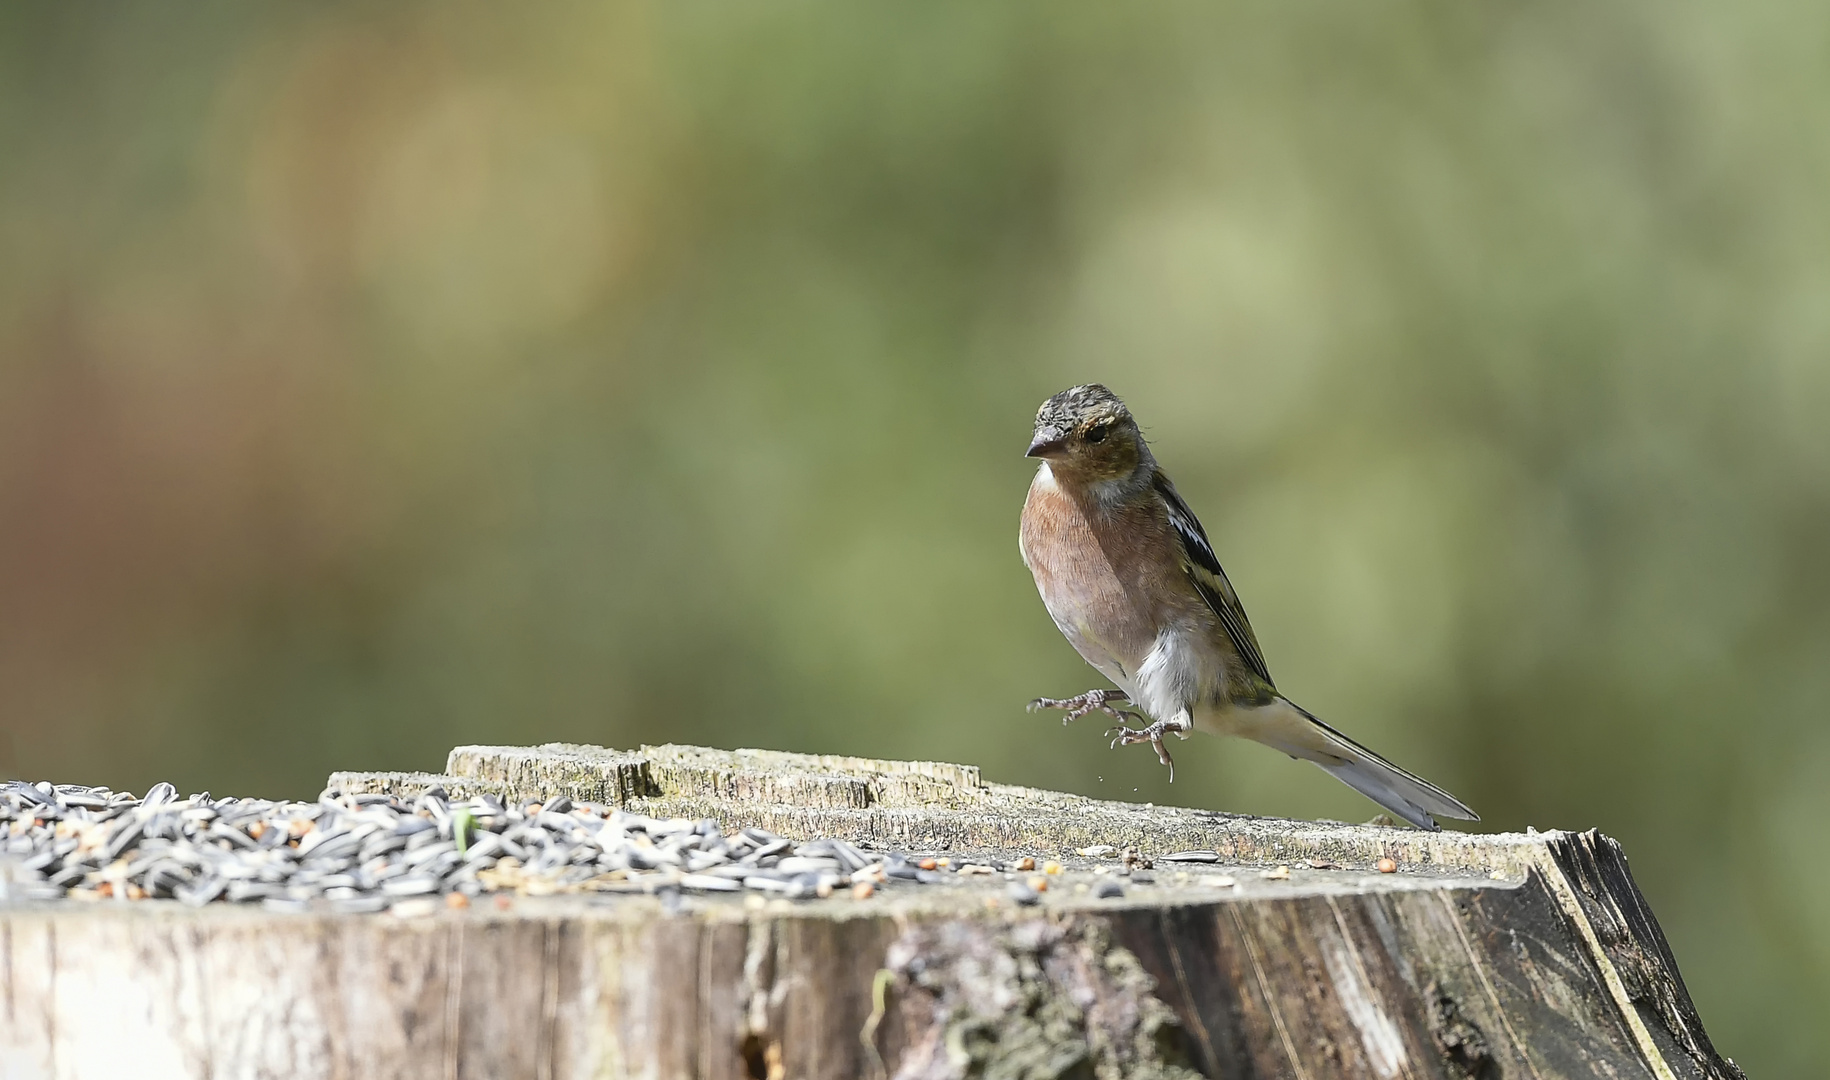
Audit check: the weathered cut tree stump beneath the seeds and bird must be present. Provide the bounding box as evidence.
[0,745,1740,1080]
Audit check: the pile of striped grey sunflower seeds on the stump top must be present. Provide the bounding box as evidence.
[0,782,1076,912]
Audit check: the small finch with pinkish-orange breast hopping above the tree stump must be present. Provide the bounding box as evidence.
[1017,383,1480,831]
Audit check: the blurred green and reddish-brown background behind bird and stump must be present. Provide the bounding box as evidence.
[0,2,1830,1078]
